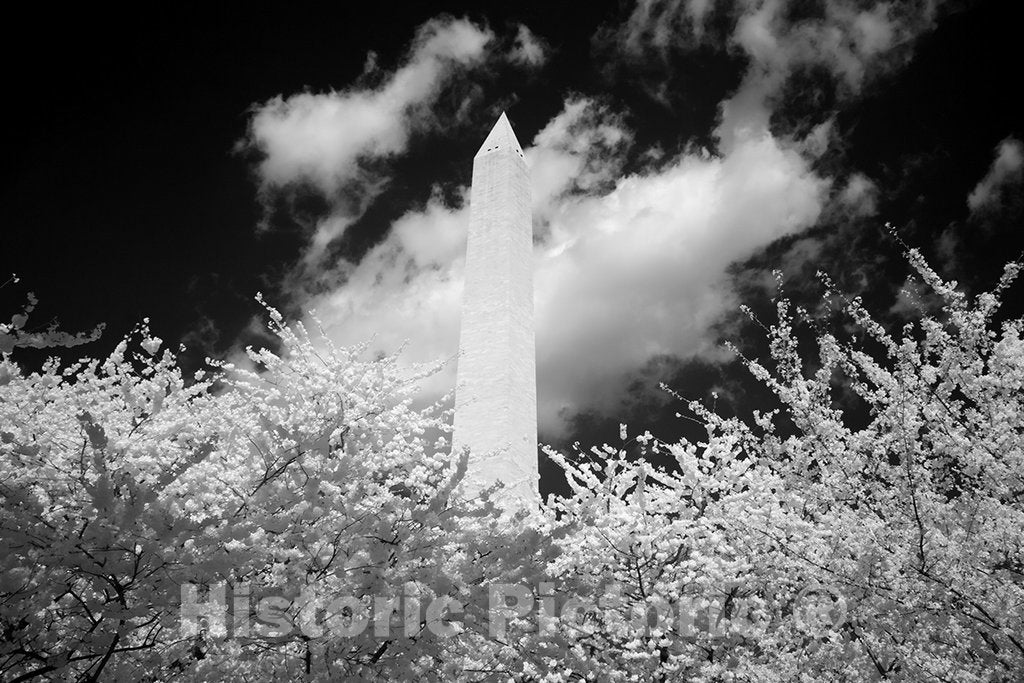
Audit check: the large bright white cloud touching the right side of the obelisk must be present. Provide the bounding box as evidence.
[527,101,827,429]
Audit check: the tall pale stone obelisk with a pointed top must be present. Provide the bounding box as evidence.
[453,113,540,512]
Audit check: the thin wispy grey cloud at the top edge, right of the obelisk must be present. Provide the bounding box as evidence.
[604,0,942,151]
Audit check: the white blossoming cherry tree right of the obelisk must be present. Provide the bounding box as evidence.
[536,250,1024,681]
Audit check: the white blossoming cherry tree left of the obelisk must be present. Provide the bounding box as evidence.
[0,296,520,680]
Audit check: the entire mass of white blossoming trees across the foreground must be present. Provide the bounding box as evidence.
[0,252,1024,681]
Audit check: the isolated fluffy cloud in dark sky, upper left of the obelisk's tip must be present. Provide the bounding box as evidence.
[246,18,494,267]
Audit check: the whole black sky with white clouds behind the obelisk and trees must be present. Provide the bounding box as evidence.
[0,0,1024,489]
